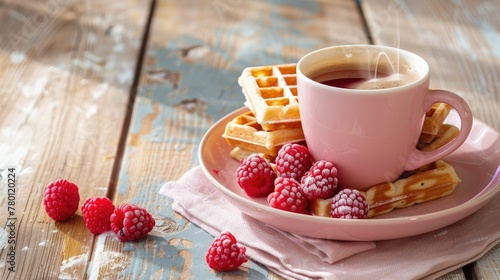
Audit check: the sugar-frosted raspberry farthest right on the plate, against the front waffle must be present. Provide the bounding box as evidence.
[330,189,368,219]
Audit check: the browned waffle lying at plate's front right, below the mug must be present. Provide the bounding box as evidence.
[310,160,461,218]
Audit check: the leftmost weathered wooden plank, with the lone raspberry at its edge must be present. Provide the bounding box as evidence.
[0,0,148,279]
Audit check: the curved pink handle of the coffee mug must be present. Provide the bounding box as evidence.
[403,89,473,171]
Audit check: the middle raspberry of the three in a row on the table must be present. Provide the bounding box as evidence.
[82,196,115,234]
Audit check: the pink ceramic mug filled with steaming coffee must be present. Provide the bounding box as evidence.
[297,45,472,190]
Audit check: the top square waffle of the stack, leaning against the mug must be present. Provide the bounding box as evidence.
[238,63,300,130]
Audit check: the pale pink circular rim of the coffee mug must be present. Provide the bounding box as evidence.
[296,44,430,94]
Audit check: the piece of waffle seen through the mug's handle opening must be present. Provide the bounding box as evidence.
[419,103,451,143]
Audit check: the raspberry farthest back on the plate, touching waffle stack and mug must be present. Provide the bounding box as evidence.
[275,143,312,181]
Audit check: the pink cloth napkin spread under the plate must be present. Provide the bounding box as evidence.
[160,166,500,279]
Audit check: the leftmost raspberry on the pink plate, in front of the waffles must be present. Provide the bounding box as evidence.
[236,154,276,197]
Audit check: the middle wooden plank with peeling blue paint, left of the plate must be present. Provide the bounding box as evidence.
[108,0,367,279]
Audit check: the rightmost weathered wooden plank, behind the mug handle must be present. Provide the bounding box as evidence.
[362,0,500,279]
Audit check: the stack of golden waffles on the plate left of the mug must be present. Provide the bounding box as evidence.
[222,64,305,159]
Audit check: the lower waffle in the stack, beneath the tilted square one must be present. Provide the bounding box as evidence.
[222,111,305,158]
